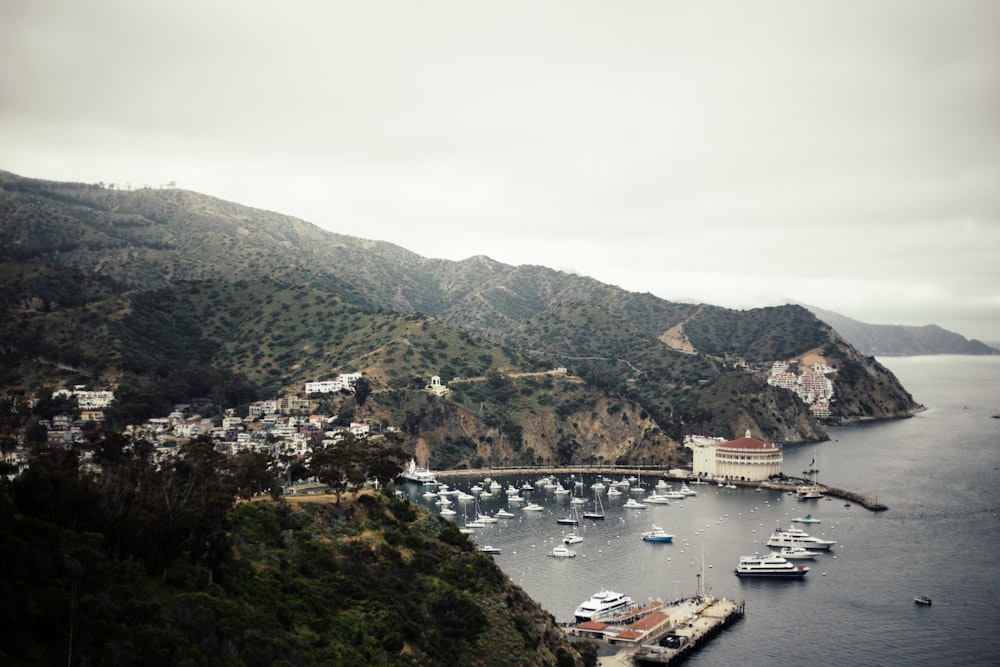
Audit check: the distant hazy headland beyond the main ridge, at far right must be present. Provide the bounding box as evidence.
[802,304,1000,357]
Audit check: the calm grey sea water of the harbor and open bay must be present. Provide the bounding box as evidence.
[402,356,1000,667]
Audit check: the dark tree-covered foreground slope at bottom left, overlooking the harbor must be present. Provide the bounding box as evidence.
[0,441,593,667]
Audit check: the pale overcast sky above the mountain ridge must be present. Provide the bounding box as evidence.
[0,0,1000,342]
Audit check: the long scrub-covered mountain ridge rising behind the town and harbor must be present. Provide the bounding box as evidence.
[0,173,917,465]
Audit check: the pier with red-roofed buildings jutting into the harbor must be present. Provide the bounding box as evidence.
[567,596,744,666]
